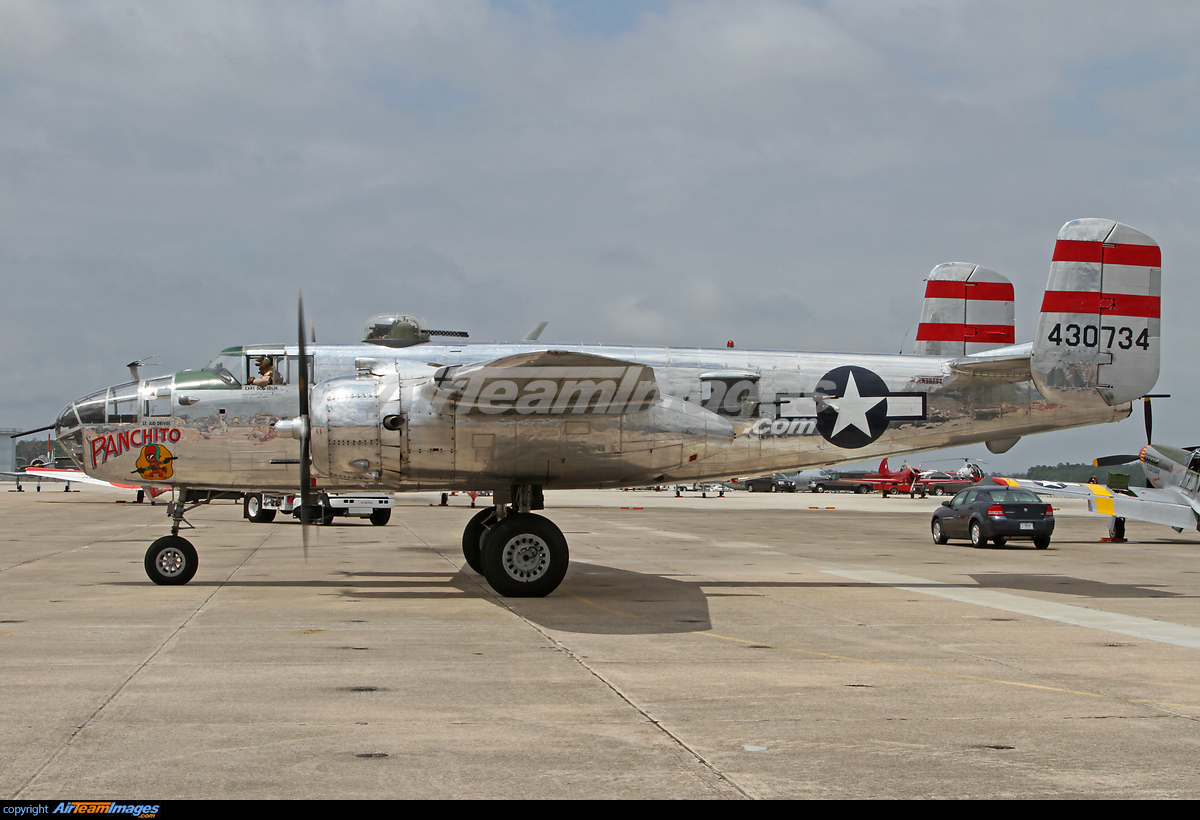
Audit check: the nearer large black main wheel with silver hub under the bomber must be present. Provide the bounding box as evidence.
[481,513,570,598]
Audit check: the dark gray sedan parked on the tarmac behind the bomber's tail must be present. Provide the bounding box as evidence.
[930,486,1054,550]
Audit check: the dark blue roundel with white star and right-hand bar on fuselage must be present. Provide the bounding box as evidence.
[812,365,925,449]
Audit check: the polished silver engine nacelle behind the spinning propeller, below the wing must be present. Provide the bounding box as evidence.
[311,373,734,490]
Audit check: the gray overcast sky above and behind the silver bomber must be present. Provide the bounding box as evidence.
[0,0,1200,471]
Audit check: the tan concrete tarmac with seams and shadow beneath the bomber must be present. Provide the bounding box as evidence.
[0,485,1200,801]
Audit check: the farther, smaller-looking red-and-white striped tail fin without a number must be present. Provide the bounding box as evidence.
[913,262,1014,355]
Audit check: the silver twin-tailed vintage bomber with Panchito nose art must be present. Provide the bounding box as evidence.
[56,219,1160,597]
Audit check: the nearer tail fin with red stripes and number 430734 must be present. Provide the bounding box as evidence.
[1031,219,1162,407]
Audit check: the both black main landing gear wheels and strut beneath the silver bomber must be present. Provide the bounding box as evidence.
[462,486,570,598]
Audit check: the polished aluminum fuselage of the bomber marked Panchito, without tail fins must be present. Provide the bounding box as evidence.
[59,343,1130,491]
